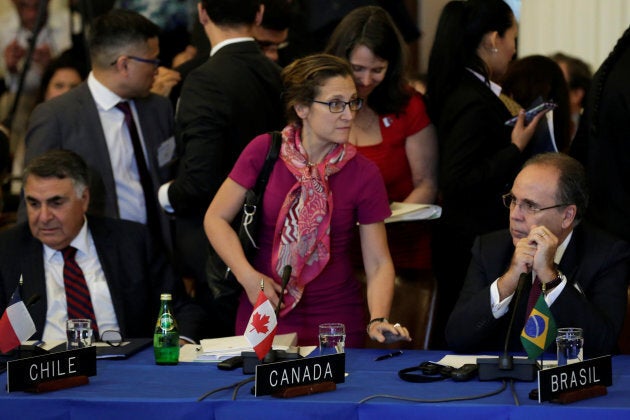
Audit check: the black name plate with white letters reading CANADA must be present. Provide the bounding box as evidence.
[254,353,346,397]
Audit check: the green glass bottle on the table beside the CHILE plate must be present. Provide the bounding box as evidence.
[153,293,179,365]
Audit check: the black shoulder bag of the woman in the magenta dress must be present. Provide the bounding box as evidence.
[206,131,282,302]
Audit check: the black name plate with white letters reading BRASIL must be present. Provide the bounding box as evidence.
[538,356,612,402]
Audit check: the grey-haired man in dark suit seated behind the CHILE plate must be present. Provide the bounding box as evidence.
[0,150,205,341]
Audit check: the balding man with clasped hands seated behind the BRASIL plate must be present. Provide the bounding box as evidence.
[446,153,630,357]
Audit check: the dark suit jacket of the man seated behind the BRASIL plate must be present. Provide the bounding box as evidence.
[446,224,630,357]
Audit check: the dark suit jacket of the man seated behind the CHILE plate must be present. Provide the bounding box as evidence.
[0,217,204,339]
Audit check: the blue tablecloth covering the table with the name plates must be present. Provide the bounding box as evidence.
[0,348,630,420]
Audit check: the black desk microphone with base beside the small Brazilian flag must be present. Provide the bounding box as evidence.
[477,273,538,381]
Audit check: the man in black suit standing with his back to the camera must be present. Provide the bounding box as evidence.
[159,0,283,335]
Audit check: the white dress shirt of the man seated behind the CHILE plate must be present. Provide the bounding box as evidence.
[42,220,120,341]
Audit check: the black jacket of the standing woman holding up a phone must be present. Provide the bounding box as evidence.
[437,71,523,236]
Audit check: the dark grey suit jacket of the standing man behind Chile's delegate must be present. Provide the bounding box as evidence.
[19,82,174,251]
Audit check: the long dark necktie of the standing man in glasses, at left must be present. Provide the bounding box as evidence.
[116,102,161,239]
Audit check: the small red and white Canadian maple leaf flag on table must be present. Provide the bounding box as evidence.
[245,290,278,360]
